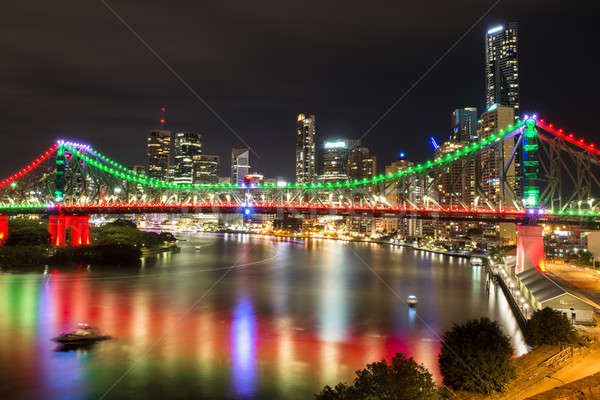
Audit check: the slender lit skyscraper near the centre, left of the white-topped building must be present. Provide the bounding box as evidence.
[296,114,316,183]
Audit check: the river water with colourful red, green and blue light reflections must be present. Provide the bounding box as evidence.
[0,234,526,399]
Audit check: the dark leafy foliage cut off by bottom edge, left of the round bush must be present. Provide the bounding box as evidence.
[315,353,438,400]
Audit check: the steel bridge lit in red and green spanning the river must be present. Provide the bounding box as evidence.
[0,115,600,267]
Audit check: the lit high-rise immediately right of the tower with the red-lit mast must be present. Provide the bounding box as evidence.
[173,132,202,185]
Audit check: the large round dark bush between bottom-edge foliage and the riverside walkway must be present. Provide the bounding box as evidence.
[438,318,515,394]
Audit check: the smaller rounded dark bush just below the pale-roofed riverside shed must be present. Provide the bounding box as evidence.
[525,307,577,347]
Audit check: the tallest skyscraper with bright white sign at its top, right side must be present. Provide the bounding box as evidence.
[485,22,519,116]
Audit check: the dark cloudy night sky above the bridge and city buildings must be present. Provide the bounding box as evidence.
[0,0,600,179]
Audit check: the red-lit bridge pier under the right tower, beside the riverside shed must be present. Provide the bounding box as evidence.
[515,225,546,274]
